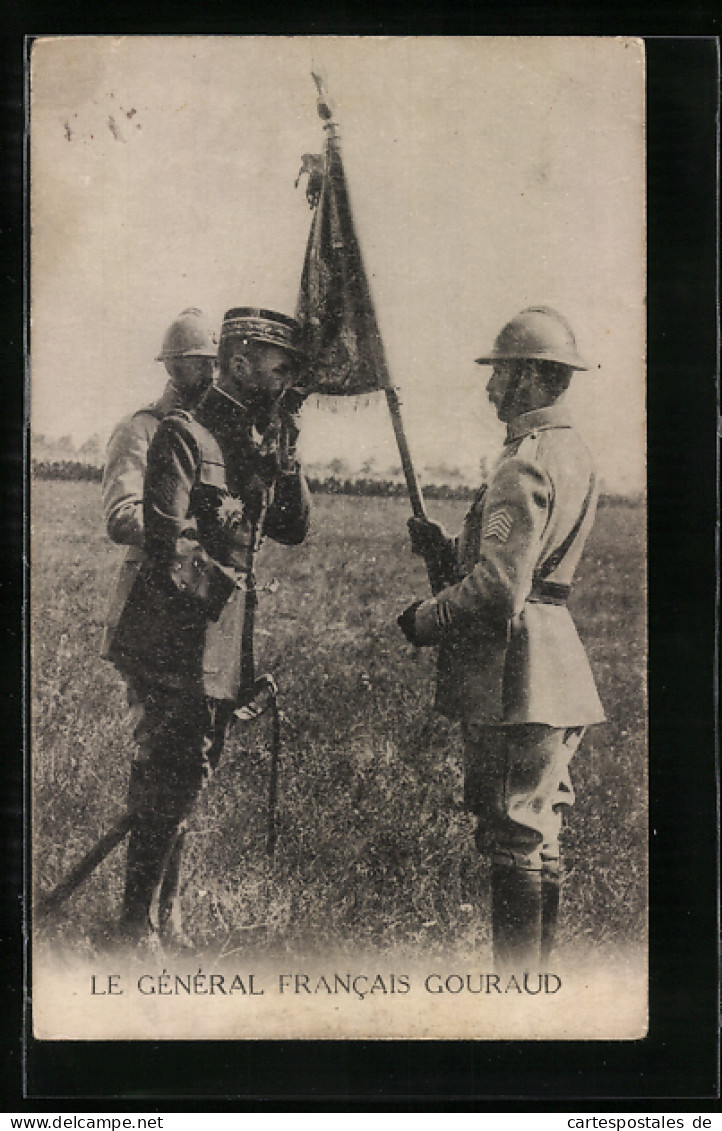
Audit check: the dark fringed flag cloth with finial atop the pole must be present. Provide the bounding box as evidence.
[295,76,390,397]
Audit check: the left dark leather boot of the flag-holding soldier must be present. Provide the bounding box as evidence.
[491,864,542,974]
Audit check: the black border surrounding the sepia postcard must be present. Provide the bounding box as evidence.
[1,30,719,1112]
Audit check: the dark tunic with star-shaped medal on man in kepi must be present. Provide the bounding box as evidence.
[109,389,310,700]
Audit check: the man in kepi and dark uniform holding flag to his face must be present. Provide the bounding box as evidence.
[106,308,310,946]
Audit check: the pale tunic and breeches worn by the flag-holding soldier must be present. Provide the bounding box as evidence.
[415,403,604,875]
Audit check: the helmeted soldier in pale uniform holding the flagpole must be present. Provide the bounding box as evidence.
[398,307,604,970]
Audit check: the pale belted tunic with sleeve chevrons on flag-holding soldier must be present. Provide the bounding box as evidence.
[416,404,604,727]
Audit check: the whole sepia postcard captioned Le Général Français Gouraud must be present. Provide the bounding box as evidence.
[28,35,648,1041]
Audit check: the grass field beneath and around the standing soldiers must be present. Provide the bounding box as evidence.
[32,481,647,956]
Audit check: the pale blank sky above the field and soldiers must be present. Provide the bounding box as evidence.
[29,36,645,492]
